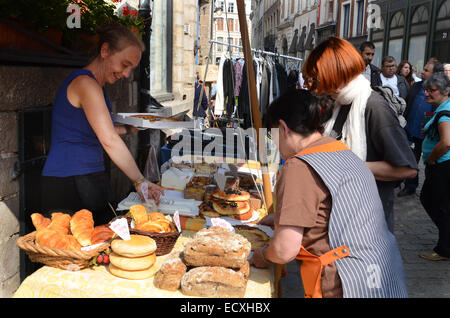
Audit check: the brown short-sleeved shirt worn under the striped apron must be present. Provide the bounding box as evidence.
[275,137,343,297]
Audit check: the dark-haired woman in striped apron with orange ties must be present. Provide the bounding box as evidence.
[251,90,407,298]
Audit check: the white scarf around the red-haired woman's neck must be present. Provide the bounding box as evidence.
[324,75,372,161]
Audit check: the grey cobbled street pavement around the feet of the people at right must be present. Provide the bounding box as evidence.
[282,165,450,298]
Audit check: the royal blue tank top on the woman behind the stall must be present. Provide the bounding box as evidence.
[42,69,112,177]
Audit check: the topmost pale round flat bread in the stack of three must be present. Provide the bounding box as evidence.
[111,234,157,257]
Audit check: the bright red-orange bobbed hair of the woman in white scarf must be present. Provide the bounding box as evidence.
[303,37,366,95]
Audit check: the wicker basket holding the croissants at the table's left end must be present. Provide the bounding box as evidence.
[17,232,110,271]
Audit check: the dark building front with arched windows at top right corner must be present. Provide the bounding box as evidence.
[370,0,450,72]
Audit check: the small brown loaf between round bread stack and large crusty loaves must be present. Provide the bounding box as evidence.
[153,251,187,291]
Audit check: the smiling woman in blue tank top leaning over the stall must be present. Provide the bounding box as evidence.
[42,23,163,224]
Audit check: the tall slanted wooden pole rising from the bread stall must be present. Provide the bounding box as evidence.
[236,0,273,213]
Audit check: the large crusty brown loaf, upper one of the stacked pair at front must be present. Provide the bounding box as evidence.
[184,227,251,268]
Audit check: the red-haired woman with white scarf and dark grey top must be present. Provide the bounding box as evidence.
[303,37,417,233]
